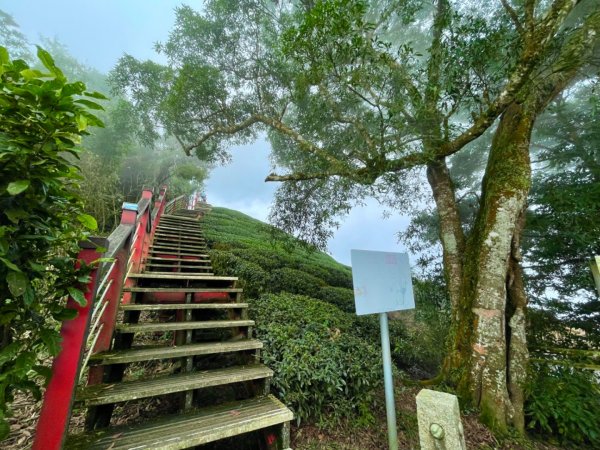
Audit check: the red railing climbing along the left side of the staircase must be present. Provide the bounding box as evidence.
[32,187,177,450]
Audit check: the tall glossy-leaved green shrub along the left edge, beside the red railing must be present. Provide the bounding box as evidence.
[0,47,104,437]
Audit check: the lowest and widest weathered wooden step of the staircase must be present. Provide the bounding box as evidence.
[65,395,294,450]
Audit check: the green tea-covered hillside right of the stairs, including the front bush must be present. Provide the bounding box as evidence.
[204,208,447,424]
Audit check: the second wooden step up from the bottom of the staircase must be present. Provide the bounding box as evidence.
[75,364,273,406]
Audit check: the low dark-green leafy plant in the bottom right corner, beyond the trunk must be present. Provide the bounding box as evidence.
[525,364,600,448]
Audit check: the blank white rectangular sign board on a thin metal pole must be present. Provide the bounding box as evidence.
[351,250,415,316]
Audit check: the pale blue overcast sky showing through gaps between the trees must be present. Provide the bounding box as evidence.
[0,0,415,264]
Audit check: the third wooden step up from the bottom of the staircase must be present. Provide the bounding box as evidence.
[89,339,263,365]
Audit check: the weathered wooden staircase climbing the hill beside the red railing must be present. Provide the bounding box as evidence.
[64,209,293,450]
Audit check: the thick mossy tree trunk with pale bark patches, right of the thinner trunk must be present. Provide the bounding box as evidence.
[452,103,535,432]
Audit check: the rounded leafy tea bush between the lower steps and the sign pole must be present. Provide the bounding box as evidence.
[250,294,382,425]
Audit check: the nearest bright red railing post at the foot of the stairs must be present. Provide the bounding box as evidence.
[32,238,106,450]
